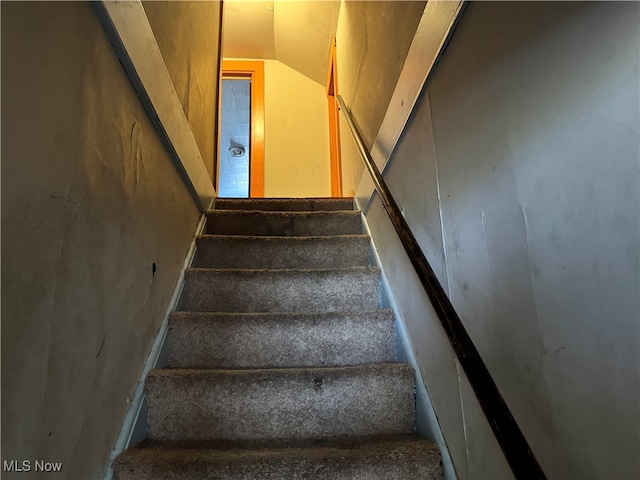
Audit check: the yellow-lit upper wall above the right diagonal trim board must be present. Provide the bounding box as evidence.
[336,0,426,195]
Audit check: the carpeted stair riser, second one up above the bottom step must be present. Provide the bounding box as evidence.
[169,310,395,368]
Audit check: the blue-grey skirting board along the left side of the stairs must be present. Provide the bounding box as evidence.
[104,214,207,480]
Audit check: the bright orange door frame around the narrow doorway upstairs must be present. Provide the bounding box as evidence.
[222,60,264,198]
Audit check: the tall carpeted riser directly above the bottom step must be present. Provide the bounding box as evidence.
[146,364,414,441]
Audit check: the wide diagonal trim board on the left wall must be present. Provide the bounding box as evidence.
[93,0,216,213]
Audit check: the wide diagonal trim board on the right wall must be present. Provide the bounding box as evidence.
[356,0,467,208]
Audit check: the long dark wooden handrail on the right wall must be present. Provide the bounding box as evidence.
[337,95,546,480]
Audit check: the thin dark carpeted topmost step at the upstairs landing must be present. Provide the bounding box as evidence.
[215,198,354,212]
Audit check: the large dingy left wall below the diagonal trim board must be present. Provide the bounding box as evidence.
[2,2,198,479]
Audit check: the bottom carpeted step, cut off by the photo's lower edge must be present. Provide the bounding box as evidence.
[114,435,444,480]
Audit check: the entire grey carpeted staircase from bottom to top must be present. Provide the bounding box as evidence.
[114,199,443,480]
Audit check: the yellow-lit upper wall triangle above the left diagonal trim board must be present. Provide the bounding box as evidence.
[143,0,222,183]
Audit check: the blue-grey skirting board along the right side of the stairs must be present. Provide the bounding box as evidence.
[355,208,458,480]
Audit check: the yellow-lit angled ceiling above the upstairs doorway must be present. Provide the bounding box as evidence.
[223,0,340,86]
